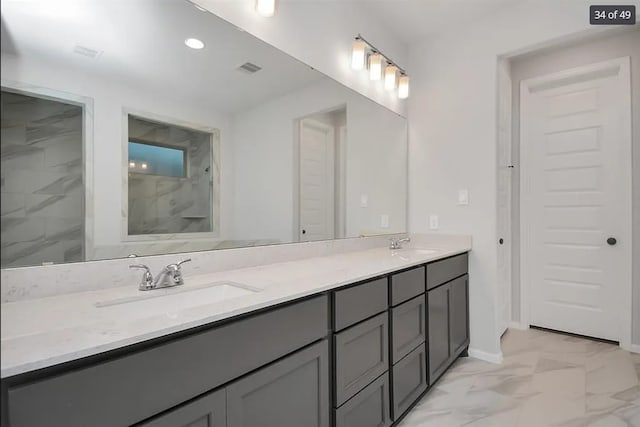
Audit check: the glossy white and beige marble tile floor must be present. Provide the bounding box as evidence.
[399,329,640,427]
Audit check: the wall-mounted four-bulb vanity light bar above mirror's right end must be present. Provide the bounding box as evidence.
[351,34,409,99]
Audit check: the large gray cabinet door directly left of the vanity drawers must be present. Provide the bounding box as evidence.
[227,340,330,427]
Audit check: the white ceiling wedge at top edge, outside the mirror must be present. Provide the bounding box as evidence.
[350,0,518,44]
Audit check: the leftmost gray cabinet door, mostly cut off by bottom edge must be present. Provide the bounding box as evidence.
[140,389,227,427]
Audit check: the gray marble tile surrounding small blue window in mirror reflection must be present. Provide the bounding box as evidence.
[128,115,214,235]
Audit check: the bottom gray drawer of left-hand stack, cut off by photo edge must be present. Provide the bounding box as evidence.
[336,374,391,427]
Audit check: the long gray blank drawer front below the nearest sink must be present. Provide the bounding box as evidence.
[8,295,329,427]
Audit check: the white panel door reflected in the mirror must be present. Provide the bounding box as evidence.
[298,119,335,242]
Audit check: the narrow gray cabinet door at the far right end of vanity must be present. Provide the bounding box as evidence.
[449,275,469,357]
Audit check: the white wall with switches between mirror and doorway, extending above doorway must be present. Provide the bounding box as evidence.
[408,0,638,357]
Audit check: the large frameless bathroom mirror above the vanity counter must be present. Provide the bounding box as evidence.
[1,0,407,268]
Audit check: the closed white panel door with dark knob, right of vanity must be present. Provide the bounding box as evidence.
[521,58,631,341]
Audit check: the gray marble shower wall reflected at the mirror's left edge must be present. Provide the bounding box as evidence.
[0,90,84,268]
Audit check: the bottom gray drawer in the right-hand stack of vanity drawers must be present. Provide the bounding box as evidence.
[393,344,427,420]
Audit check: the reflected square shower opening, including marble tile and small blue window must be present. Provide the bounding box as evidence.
[128,115,214,235]
